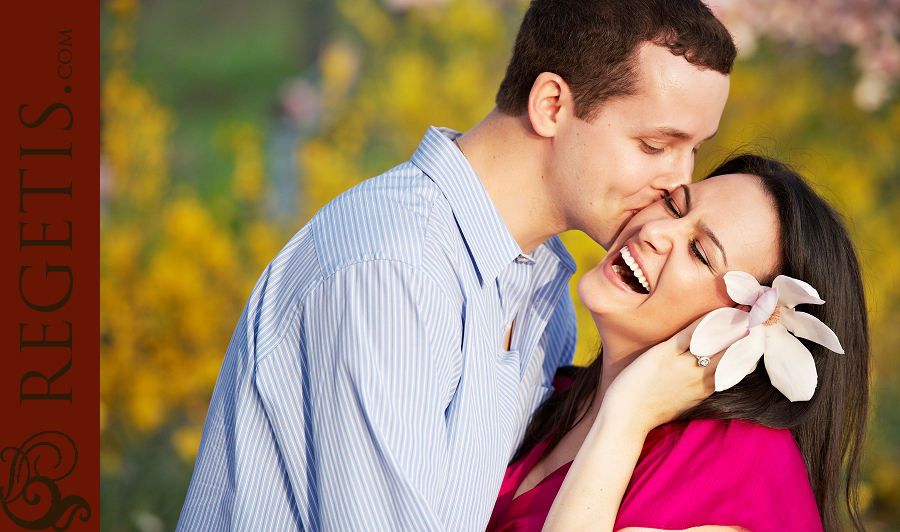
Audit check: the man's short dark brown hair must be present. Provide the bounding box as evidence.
[496,0,737,120]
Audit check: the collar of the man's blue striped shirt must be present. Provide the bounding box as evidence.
[411,127,575,282]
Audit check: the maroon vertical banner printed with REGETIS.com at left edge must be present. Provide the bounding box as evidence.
[0,0,100,531]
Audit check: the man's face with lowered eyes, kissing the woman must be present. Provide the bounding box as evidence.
[546,43,729,248]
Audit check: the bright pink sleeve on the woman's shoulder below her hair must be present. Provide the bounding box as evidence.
[615,420,822,532]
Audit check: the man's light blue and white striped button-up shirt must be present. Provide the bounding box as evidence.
[178,128,575,532]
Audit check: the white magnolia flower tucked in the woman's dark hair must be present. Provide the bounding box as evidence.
[691,272,844,401]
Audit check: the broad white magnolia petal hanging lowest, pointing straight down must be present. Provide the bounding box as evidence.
[763,323,819,401]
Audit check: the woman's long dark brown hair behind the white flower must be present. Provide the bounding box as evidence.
[518,154,869,532]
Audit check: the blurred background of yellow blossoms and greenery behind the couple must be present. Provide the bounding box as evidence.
[100,0,900,532]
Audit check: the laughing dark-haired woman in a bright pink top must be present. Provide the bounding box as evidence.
[488,155,869,532]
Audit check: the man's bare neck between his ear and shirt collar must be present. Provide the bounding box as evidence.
[460,109,566,253]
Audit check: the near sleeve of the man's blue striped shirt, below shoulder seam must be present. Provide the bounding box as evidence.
[256,260,461,531]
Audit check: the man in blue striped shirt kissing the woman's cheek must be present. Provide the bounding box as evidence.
[178,0,735,531]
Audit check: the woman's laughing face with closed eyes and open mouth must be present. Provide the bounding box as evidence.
[578,174,781,349]
